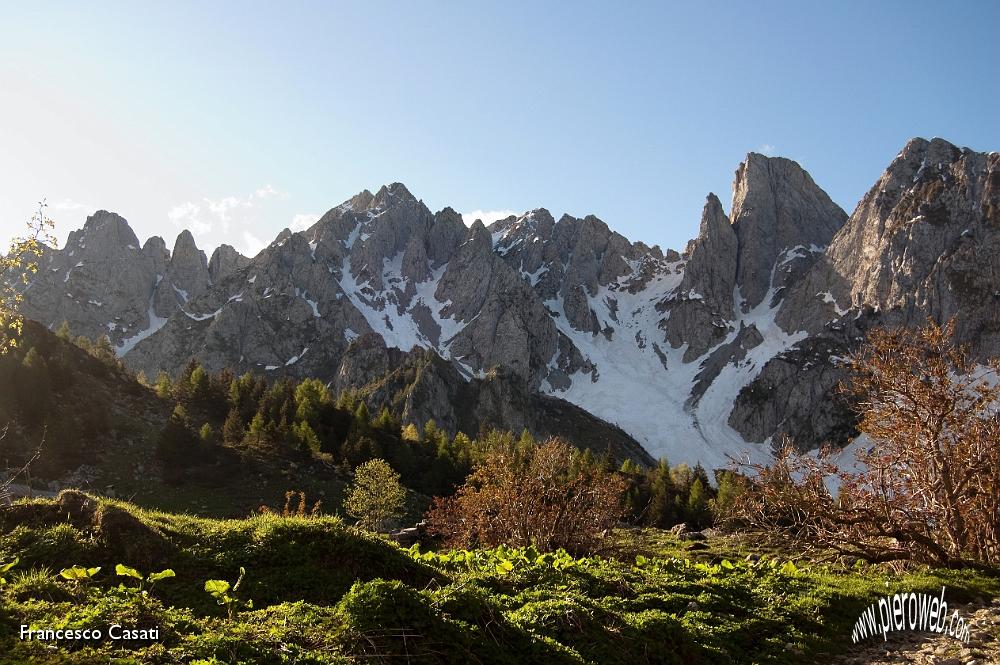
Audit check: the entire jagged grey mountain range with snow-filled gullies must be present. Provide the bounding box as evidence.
[17,139,1000,466]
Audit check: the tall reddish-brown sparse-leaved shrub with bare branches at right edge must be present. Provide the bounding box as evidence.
[736,321,1000,566]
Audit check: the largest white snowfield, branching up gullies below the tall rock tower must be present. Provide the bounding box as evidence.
[542,260,806,468]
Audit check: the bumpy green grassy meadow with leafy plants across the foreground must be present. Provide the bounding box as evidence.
[0,494,1000,665]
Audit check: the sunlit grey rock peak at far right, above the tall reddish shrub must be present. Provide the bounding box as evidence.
[730,139,1000,447]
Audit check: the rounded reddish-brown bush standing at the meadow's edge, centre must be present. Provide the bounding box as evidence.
[428,438,626,554]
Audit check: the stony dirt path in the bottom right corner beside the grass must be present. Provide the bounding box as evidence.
[832,598,1000,665]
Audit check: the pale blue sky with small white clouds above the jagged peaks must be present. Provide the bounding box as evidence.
[0,0,1000,252]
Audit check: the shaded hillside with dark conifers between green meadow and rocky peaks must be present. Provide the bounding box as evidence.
[0,321,728,527]
